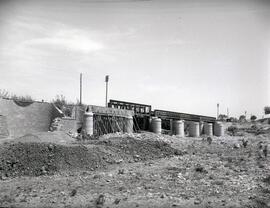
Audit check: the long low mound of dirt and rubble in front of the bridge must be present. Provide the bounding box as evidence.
[0,138,180,179]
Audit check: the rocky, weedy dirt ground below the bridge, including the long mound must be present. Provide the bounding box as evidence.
[0,124,270,208]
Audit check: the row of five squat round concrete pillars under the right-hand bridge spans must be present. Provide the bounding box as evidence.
[151,117,224,137]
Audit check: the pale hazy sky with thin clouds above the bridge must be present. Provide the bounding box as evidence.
[0,0,270,117]
